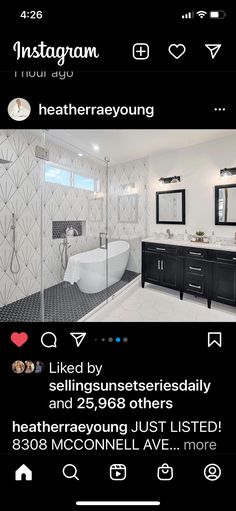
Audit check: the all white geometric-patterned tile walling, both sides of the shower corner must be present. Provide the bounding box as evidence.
[0,129,148,307]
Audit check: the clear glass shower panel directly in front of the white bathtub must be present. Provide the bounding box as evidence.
[42,130,107,322]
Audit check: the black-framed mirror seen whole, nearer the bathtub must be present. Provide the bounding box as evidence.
[156,190,185,224]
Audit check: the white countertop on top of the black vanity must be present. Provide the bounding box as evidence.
[142,237,236,252]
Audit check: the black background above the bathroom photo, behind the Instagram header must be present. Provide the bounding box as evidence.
[0,2,236,129]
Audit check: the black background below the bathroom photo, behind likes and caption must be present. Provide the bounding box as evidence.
[1,323,235,510]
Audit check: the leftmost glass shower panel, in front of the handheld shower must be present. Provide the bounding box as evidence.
[0,129,43,321]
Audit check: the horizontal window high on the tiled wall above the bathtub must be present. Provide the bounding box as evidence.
[45,163,97,192]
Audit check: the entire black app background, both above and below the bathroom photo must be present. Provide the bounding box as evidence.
[0,2,236,511]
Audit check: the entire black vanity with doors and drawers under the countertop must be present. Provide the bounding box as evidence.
[142,242,236,307]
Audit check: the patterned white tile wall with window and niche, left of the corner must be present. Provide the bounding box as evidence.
[0,130,106,306]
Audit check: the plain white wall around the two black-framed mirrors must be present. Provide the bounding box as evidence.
[148,135,236,237]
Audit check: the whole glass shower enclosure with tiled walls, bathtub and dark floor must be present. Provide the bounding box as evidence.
[0,129,147,322]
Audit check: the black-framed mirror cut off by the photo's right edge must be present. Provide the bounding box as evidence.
[215,184,236,225]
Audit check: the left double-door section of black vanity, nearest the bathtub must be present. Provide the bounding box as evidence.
[142,242,179,289]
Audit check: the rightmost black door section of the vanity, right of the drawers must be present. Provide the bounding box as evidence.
[209,250,236,306]
